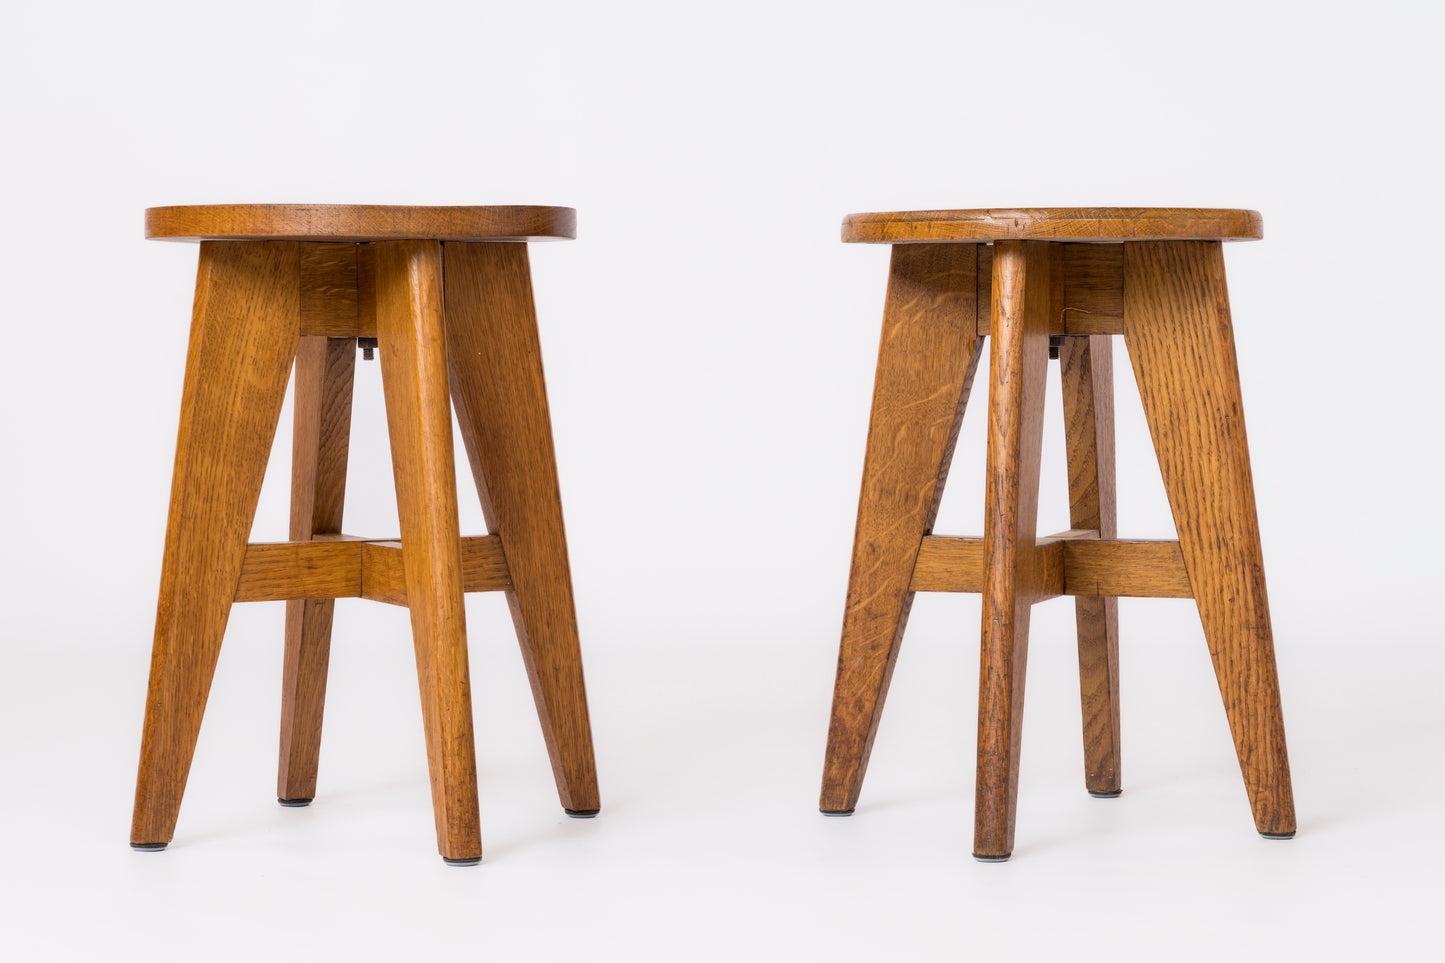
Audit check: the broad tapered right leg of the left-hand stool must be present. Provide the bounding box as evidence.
[444,243,600,816]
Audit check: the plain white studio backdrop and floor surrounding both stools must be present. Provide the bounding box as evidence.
[0,0,1445,960]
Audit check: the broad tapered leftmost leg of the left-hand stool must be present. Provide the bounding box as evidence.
[130,241,301,849]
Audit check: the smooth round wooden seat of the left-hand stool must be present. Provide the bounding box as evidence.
[146,204,577,241]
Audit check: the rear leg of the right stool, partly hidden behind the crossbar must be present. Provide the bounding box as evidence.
[1059,334,1120,797]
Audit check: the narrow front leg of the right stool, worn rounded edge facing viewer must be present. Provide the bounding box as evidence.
[974,241,1053,860]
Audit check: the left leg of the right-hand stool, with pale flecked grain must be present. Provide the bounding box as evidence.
[818,244,988,814]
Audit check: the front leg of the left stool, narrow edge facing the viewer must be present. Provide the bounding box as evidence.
[376,241,481,863]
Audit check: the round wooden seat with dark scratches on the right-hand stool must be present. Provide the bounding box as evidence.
[842,207,1264,244]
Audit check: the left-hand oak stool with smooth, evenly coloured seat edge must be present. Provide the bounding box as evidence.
[130,204,598,863]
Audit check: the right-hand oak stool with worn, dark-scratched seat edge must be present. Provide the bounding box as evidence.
[819,208,1295,860]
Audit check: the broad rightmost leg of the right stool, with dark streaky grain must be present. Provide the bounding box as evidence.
[1124,241,1295,837]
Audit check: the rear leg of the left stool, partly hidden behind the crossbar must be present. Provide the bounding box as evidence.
[276,337,357,805]
